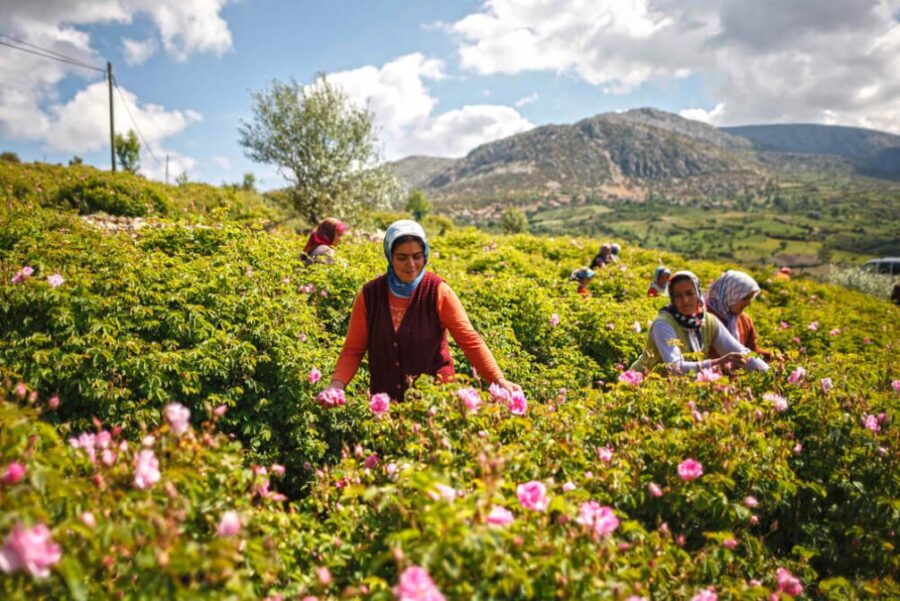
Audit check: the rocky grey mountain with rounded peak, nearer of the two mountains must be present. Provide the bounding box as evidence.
[392,109,767,204]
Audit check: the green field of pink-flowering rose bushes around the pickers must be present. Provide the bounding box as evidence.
[0,165,900,601]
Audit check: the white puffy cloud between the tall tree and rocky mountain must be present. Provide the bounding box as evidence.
[327,53,533,159]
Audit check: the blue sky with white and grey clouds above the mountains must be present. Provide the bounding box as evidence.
[0,0,900,188]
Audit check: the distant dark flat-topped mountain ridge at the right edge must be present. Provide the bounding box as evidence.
[721,123,900,178]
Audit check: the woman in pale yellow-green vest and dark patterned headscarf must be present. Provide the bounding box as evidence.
[631,271,769,374]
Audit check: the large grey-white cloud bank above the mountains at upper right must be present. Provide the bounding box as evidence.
[454,0,900,133]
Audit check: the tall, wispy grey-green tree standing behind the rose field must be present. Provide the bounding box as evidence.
[239,74,397,223]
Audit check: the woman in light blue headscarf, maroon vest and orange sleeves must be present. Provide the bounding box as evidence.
[328,219,521,399]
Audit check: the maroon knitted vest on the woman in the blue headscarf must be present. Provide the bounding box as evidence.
[363,272,455,400]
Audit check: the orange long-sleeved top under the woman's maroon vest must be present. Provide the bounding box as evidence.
[333,282,503,385]
